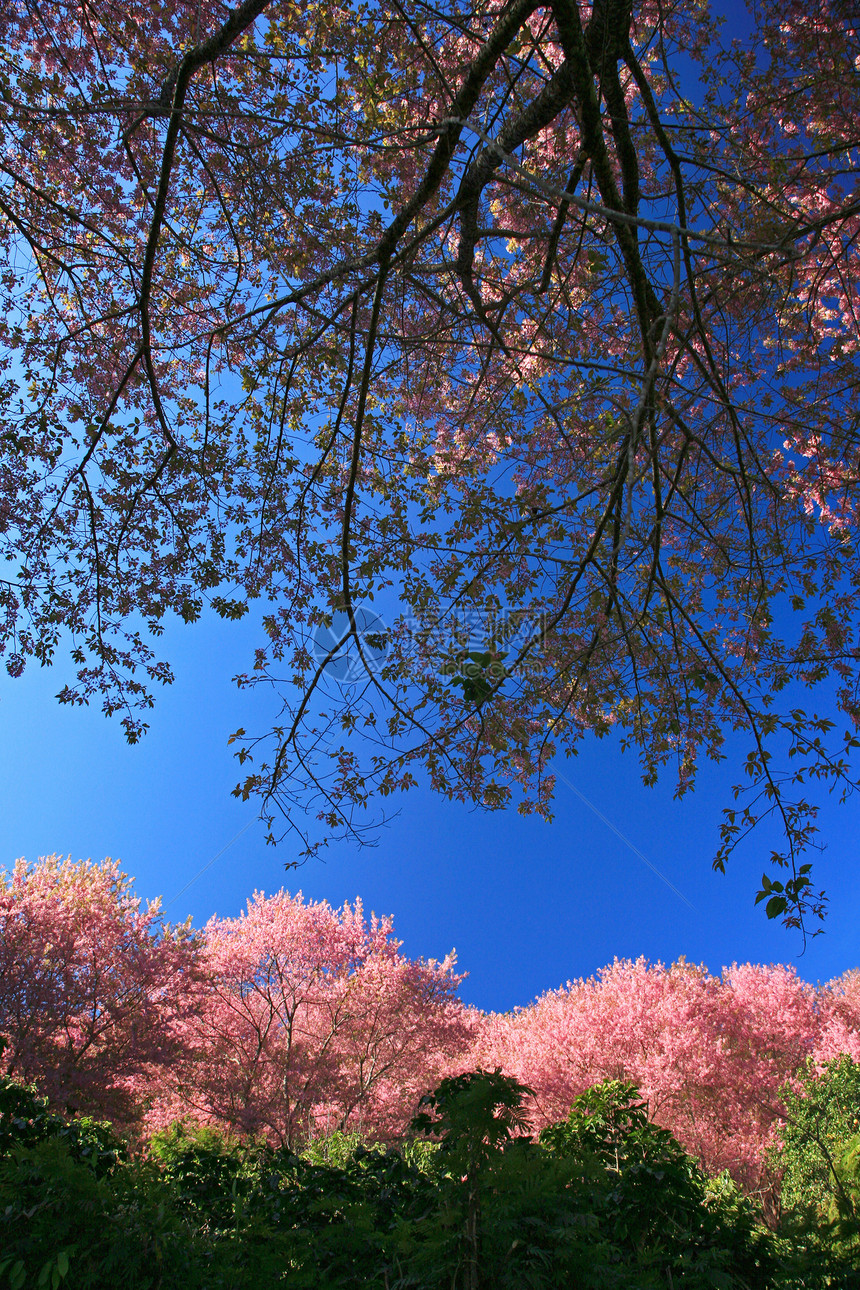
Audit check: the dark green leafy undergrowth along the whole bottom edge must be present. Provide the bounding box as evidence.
[0,1060,860,1290]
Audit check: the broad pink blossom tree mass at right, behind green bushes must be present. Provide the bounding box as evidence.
[474,958,860,1195]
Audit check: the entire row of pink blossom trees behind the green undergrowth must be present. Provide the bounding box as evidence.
[0,855,860,1197]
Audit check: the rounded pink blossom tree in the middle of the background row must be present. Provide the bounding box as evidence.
[150,891,471,1146]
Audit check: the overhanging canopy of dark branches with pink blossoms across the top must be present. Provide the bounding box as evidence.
[0,0,860,922]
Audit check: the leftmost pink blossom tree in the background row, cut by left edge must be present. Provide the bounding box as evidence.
[0,855,197,1125]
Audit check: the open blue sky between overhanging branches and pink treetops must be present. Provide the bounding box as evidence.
[0,0,860,1010]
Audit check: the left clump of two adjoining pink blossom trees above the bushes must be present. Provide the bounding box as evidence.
[0,855,474,1144]
